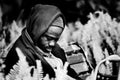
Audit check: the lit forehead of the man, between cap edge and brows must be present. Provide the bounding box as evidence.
[46,26,63,37]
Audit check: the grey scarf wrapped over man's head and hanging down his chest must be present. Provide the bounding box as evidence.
[21,4,65,77]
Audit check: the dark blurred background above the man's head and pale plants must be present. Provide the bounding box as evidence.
[0,0,120,25]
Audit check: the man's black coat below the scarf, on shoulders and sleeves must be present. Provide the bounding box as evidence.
[5,31,78,78]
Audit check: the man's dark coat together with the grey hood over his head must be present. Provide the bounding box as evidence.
[5,5,78,78]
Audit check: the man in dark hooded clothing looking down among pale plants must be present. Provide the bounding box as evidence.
[5,4,78,79]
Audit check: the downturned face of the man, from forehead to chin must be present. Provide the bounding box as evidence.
[38,26,63,53]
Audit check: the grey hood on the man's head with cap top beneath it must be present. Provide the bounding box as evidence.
[26,4,65,44]
